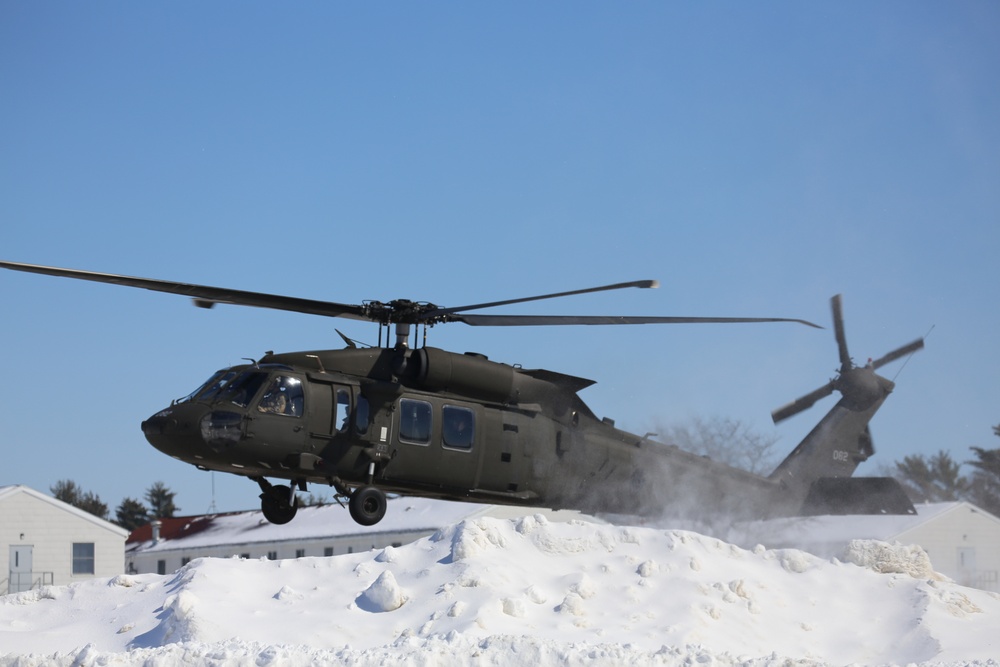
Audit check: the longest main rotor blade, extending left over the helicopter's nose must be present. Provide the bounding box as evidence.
[0,262,370,321]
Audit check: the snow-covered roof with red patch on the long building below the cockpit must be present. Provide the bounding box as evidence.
[125,497,492,555]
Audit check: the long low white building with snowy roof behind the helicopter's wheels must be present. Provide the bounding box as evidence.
[125,496,581,574]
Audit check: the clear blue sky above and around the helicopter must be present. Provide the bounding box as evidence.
[0,0,1000,513]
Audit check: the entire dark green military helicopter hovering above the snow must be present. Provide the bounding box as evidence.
[0,262,923,525]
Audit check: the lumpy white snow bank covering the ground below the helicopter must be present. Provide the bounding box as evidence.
[0,515,1000,667]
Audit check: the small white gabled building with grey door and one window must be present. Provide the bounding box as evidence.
[0,485,128,594]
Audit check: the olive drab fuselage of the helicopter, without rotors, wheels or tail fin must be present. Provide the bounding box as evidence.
[142,347,820,516]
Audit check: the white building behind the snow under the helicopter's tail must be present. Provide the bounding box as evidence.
[730,502,1000,592]
